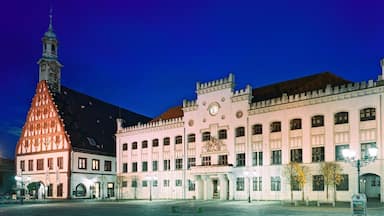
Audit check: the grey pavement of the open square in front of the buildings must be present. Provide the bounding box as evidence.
[0,200,384,216]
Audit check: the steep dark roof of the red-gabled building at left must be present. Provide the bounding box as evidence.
[54,86,151,155]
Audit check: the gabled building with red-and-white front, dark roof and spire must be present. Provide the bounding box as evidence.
[15,16,150,199]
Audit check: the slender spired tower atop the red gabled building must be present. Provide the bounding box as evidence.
[37,10,63,93]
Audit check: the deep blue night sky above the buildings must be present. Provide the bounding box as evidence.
[0,0,384,158]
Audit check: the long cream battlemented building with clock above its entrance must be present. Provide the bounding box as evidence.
[116,73,384,201]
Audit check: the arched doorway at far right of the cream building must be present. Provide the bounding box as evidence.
[360,173,381,200]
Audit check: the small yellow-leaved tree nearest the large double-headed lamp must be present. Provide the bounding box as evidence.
[320,162,343,201]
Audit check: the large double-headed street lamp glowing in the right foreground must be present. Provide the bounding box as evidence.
[342,147,378,193]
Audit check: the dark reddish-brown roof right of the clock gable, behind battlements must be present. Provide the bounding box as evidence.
[252,72,351,102]
